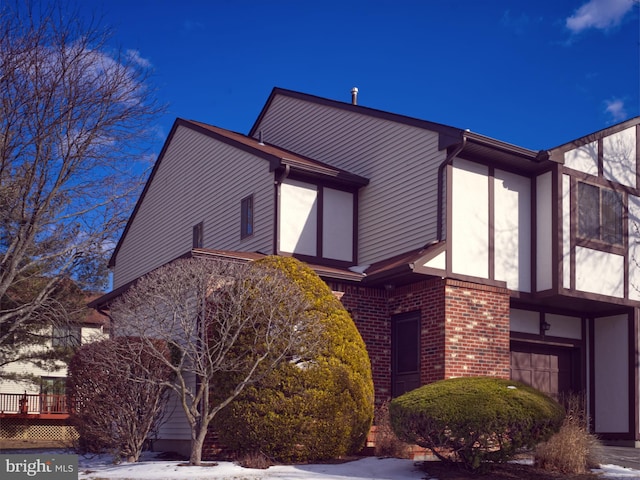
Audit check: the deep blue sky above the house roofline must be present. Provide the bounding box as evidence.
[87,0,640,152]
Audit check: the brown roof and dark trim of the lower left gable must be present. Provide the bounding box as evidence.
[109,118,369,267]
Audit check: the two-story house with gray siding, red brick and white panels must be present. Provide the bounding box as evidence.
[94,88,640,454]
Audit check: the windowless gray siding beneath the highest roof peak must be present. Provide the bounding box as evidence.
[256,96,445,264]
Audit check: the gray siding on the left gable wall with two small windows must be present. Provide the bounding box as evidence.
[113,126,274,288]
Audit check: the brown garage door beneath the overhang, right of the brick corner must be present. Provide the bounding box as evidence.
[511,342,581,399]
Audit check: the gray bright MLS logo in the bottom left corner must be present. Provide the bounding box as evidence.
[0,453,78,480]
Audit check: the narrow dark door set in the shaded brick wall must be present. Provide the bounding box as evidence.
[391,312,420,397]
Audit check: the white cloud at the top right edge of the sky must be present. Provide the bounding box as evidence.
[566,0,635,33]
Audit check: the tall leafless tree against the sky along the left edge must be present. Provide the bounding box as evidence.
[0,0,162,364]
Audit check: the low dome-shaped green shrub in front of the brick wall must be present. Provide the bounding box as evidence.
[389,377,564,470]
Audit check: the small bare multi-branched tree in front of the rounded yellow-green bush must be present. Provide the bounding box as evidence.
[111,258,322,465]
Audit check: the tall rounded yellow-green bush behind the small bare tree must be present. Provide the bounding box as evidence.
[214,257,373,462]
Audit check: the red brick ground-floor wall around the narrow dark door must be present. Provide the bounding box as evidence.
[331,278,510,403]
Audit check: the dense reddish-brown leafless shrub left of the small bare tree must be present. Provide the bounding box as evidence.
[67,337,171,462]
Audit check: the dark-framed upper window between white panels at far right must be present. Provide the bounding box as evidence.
[578,182,623,245]
